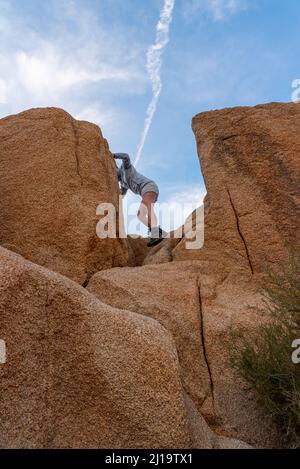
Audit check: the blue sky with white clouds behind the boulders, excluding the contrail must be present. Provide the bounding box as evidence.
[0,0,300,229]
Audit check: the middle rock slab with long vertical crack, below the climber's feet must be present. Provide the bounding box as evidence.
[87,261,281,448]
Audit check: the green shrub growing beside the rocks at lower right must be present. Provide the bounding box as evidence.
[230,252,300,448]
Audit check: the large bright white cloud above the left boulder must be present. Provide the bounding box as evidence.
[0,0,147,124]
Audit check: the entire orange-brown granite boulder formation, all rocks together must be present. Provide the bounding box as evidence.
[0,104,300,448]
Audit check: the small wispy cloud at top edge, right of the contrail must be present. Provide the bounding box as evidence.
[183,0,249,21]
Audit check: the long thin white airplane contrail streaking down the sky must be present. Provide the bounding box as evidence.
[134,0,175,165]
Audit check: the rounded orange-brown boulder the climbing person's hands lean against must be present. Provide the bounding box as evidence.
[0,108,128,283]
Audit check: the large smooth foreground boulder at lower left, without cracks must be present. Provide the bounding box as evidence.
[0,248,246,448]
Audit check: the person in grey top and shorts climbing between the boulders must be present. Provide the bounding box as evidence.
[113,153,166,247]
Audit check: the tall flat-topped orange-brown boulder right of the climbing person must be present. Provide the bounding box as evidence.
[148,103,300,274]
